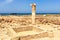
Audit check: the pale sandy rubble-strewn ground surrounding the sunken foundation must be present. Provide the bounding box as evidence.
[0,15,60,40]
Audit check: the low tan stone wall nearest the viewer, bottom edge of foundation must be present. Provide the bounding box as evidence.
[20,32,48,40]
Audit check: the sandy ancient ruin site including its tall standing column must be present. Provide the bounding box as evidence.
[0,4,60,40]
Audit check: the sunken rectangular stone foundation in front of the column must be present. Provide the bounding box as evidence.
[11,26,53,40]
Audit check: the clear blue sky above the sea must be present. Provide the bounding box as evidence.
[0,0,60,13]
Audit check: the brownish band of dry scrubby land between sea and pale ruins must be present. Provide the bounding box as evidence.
[0,15,60,25]
